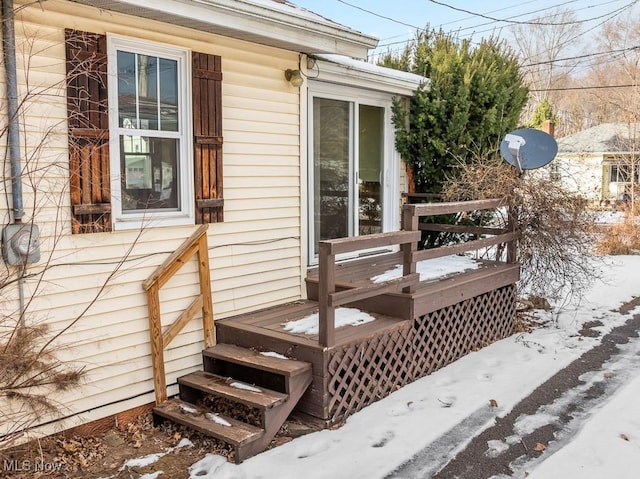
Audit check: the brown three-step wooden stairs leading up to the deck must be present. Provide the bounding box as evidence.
[153,344,311,464]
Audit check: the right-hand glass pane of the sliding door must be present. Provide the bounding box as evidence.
[358,105,384,235]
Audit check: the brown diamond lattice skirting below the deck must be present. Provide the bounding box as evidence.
[327,285,516,422]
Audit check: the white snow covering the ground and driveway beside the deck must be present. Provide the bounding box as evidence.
[106,215,640,479]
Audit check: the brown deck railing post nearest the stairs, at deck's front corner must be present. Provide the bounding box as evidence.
[318,242,336,347]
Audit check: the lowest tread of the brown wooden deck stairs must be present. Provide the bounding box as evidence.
[153,398,264,449]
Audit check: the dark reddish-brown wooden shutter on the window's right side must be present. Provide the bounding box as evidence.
[192,52,224,223]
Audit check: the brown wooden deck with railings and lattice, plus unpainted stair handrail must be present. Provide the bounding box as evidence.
[152,199,520,423]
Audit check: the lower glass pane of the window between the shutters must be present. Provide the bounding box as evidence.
[120,135,180,213]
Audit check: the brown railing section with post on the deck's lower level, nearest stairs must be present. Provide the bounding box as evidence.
[318,230,421,346]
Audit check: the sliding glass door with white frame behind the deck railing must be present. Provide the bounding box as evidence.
[309,88,397,263]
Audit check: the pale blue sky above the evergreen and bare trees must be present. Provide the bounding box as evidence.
[289,0,639,60]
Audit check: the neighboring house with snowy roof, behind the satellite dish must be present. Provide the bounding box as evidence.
[551,123,640,201]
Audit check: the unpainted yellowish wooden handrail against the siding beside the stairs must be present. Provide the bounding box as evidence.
[142,225,216,404]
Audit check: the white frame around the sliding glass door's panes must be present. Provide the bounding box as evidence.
[307,81,400,266]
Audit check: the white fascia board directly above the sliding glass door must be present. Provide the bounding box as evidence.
[307,55,429,96]
